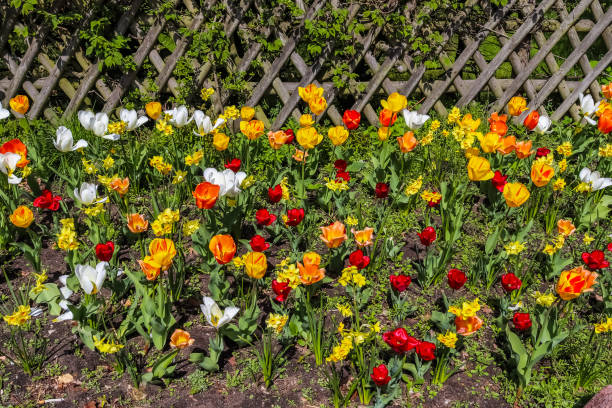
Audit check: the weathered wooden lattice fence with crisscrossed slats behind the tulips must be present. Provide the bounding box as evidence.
[0,0,612,129]
